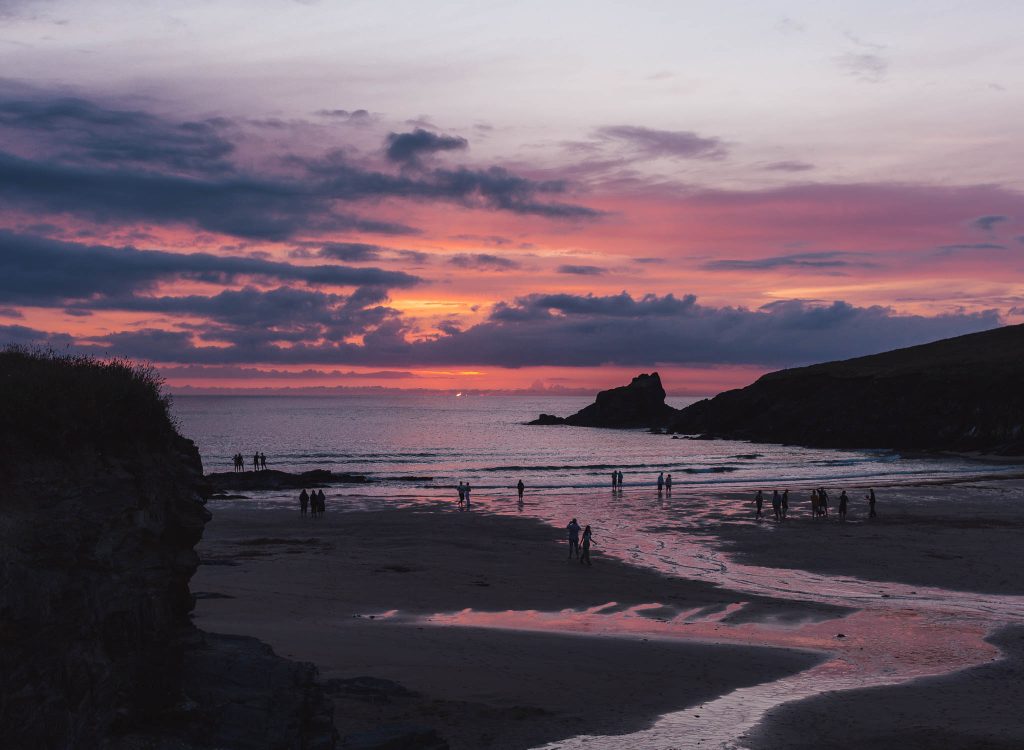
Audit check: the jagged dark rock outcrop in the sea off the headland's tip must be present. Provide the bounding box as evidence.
[529,372,677,427]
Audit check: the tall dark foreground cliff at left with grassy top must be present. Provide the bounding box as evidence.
[0,349,333,750]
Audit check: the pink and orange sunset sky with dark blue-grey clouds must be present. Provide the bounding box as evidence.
[0,0,1024,395]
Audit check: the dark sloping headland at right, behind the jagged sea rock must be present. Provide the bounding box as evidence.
[671,326,1024,455]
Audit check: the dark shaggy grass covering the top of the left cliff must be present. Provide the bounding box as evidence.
[0,346,175,455]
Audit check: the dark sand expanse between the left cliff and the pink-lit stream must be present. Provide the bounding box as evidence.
[193,507,831,748]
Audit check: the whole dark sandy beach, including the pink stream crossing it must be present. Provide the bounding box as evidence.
[193,482,1024,748]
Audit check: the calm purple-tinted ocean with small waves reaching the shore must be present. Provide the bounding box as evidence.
[173,393,1020,504]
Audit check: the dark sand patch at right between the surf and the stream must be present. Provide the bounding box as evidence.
[694,480,1024,594]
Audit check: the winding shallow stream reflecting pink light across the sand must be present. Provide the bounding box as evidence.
[356,479,1024,750]
